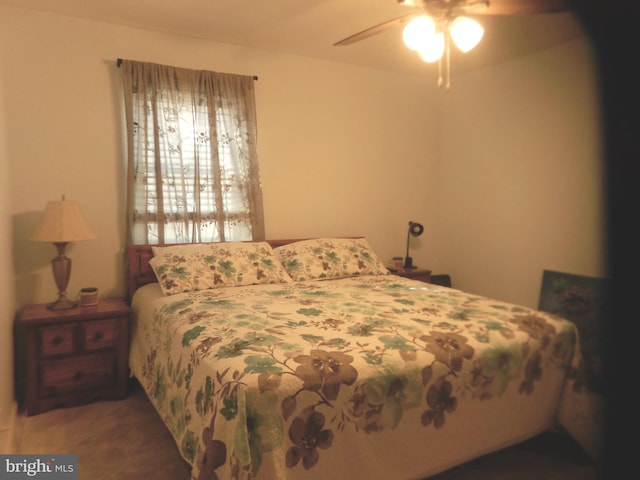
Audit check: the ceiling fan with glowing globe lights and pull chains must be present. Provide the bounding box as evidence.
[334,0,570,90]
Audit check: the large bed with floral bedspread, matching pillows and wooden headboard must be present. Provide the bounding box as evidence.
[128,238,594,480]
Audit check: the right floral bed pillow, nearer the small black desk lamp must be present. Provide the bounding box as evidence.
[274,238,389,281]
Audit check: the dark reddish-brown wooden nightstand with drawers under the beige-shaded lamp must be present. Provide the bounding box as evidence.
[19,298,131,415]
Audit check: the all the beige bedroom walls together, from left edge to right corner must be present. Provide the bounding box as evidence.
[0,7,602,427]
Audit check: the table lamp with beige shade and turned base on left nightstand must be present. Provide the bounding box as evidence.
[31,195,95,310]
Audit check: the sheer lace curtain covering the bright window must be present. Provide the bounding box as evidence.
[121,60,264,244]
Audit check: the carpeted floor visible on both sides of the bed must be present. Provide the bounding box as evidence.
[15,381,598,480]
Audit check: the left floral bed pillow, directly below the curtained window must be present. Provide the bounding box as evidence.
[149,242,291,295]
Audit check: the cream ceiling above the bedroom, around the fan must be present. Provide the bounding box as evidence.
[0,0,582,75]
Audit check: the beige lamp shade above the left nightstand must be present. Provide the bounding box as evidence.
[31,197,96,243]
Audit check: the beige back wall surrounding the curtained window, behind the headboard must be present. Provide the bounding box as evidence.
[0,4,439,312]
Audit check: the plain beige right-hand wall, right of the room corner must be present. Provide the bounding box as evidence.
[436,39,606,306]
